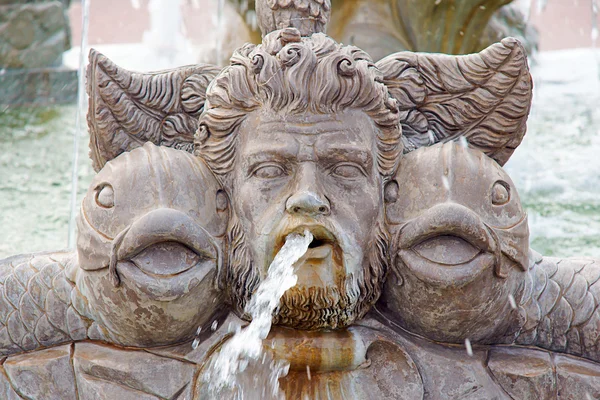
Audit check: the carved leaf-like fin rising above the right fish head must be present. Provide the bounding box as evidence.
[377,38,533,165]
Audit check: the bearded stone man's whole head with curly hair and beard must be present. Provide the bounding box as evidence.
[195,28,403,330]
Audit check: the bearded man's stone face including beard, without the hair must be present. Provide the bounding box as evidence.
[226,110,387,329]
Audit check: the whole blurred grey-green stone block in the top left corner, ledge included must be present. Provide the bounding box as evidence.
[0,0,77,104]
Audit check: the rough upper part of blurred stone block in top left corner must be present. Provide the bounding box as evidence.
[0,1,69,68]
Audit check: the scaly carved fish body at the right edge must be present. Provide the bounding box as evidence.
[515,248,600,361]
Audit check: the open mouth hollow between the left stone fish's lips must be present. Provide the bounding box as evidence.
[130,242,214,276]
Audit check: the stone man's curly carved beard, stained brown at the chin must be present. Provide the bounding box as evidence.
[224,212,390,330]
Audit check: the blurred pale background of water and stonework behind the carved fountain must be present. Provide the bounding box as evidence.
[0,0,600,258]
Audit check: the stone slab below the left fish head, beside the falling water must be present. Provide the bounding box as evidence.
[73,343,196,399]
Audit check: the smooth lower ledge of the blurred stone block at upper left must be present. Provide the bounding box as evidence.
[0,67,77,105]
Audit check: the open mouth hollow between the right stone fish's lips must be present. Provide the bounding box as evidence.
[412,235,480,265]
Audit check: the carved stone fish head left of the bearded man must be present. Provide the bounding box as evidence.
[76,143,229,346]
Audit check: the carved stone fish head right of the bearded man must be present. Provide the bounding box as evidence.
[382,142,529,343]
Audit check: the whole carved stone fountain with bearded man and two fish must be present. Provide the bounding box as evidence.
[0,0,600,400]
